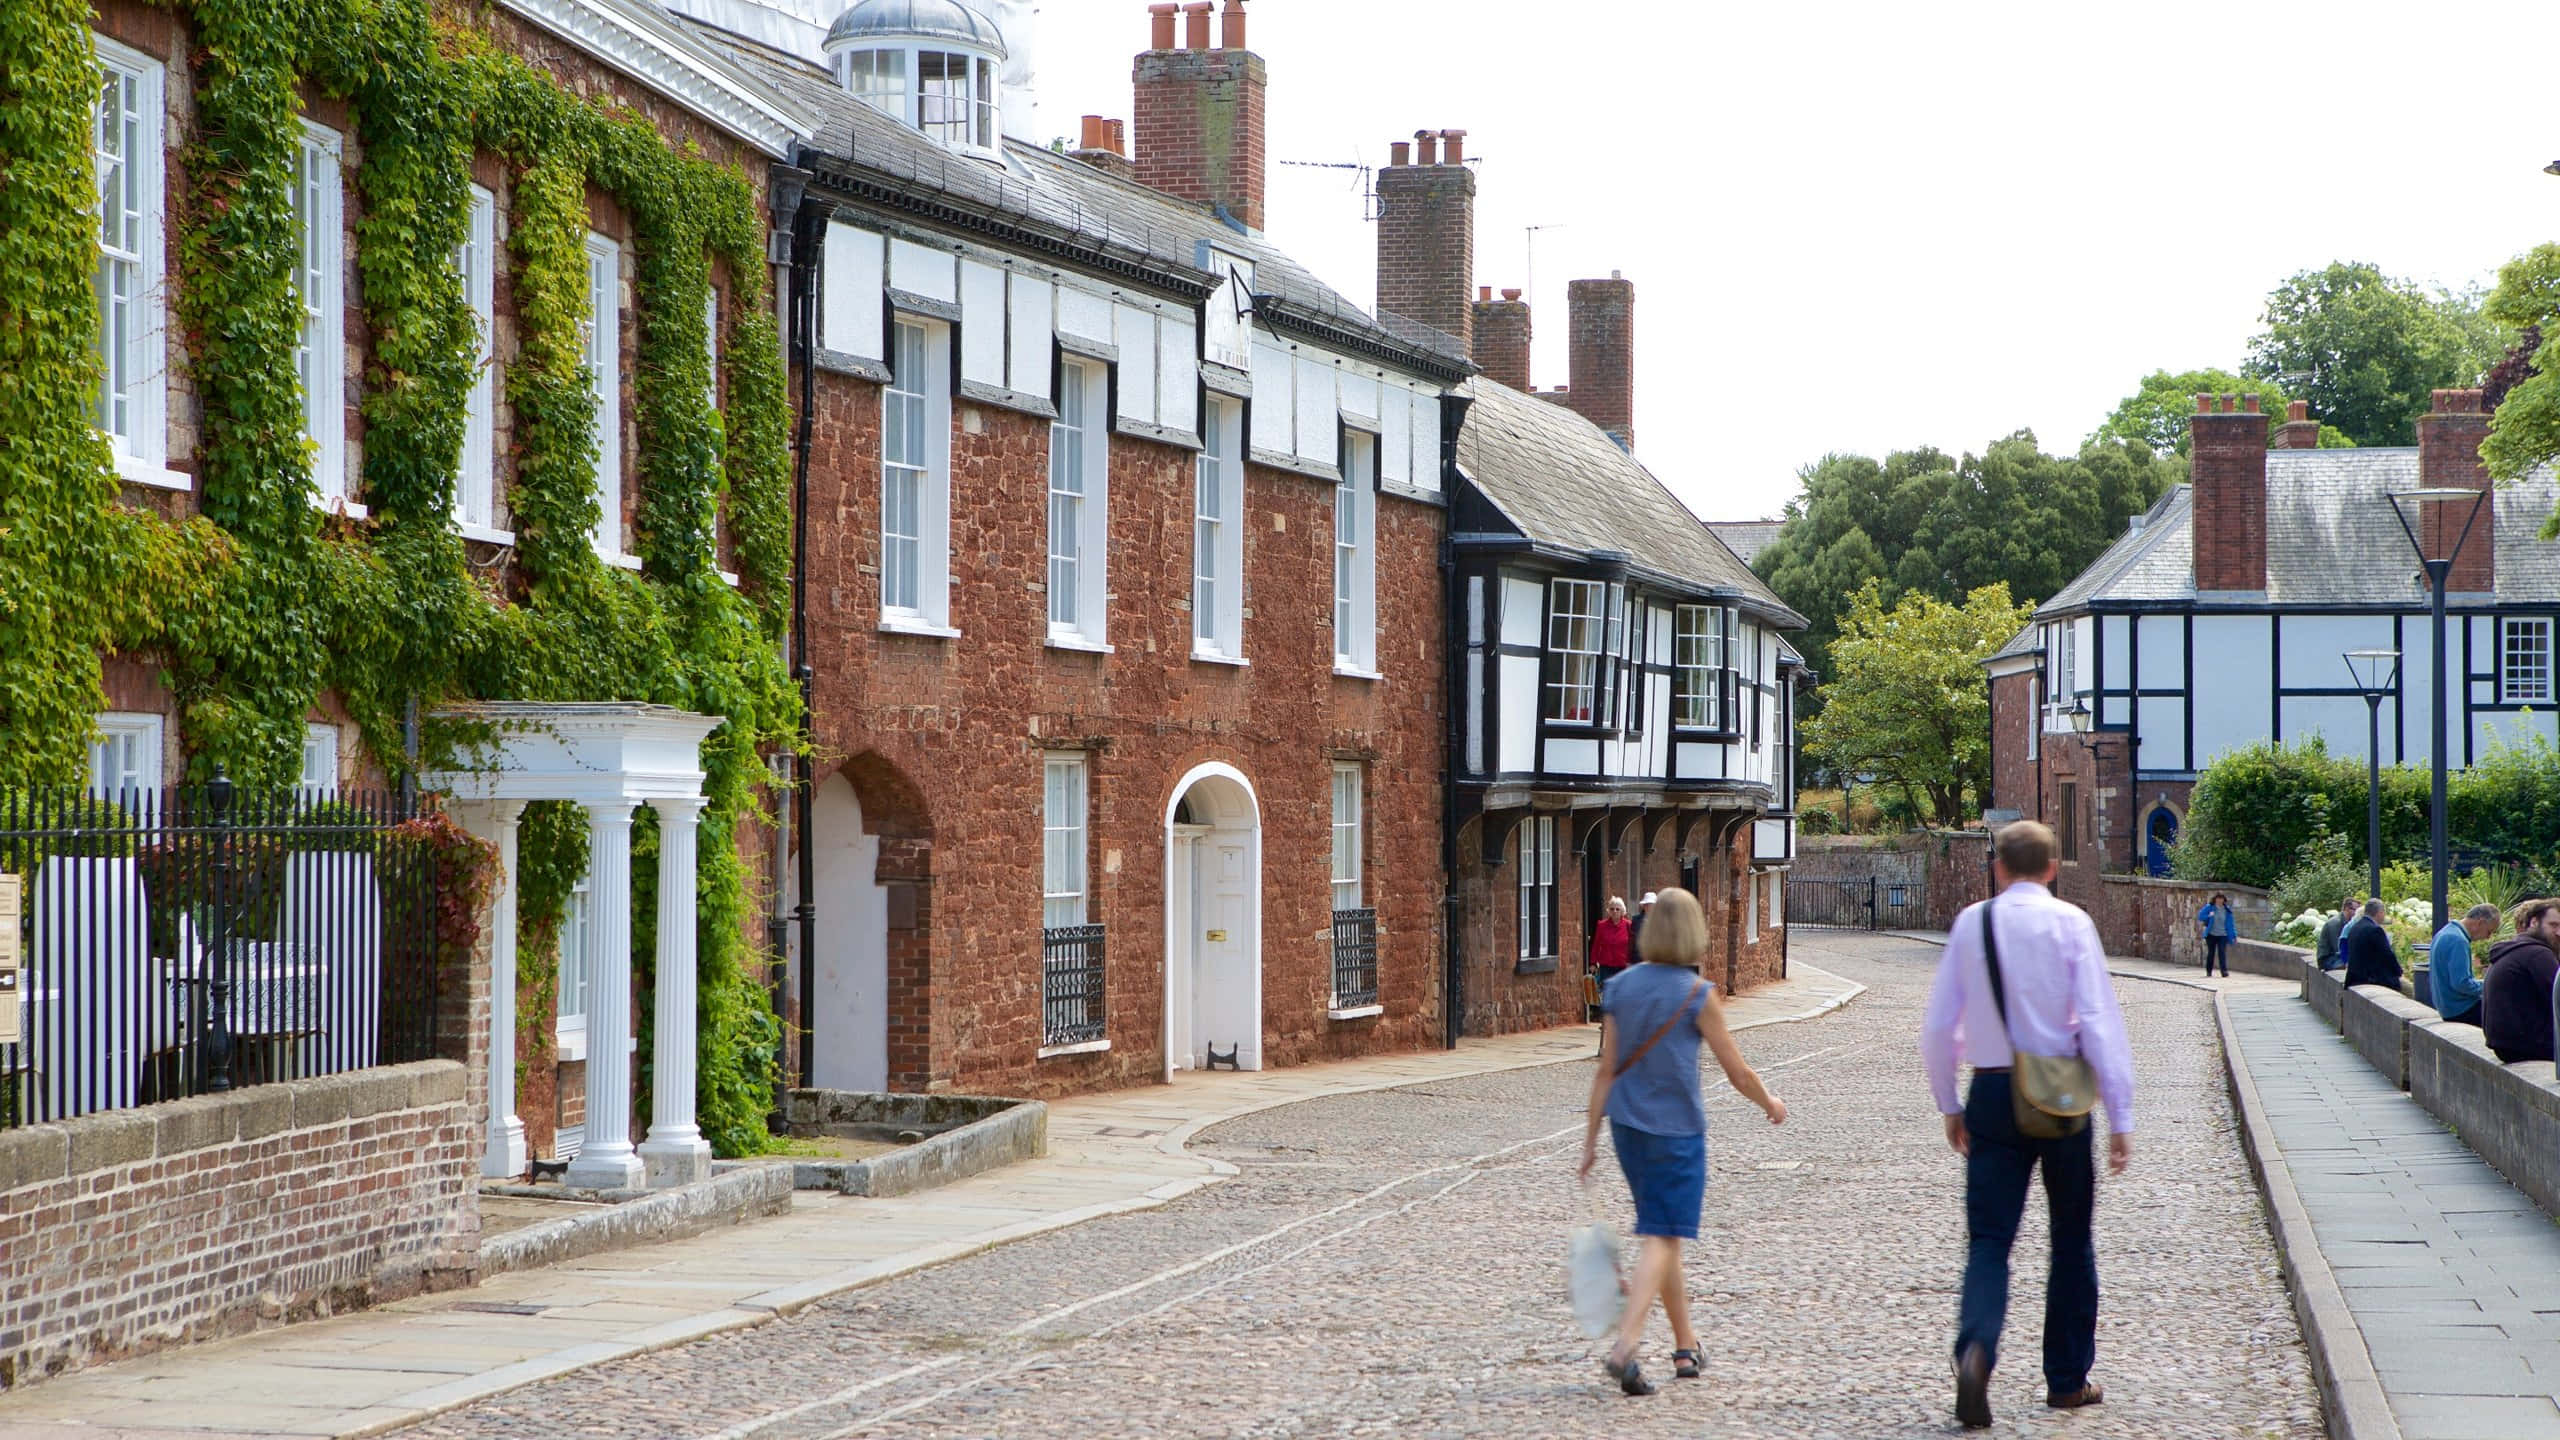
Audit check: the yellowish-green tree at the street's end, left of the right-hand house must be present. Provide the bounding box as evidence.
[1805,582,2035,820]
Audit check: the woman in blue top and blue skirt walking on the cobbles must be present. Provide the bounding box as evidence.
[1582,889,1787,1394]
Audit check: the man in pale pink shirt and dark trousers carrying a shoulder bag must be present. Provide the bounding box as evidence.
[1920,820,2132,1430]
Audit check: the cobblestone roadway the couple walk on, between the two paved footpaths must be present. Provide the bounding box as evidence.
[404,933,2322,1440]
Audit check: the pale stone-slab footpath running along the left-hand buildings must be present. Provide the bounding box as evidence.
[0,963,1864,1440]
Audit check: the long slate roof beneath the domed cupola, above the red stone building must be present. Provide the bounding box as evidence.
[696,26,1475,374]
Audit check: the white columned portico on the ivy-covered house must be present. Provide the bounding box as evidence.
[422,702,722,1189]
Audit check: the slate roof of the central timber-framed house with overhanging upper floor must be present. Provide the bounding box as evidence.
[1457,377,1805,628]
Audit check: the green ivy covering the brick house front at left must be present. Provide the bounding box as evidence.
[0,0,799,1156]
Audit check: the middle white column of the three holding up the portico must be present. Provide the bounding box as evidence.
[568,799,640,1189]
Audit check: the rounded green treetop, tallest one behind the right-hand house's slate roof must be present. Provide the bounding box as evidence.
[2240,261,2504,446]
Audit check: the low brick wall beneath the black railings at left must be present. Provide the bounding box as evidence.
[0,1061,479,1389]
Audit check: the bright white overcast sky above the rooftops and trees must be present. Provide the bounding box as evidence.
[1037,0,2560,520]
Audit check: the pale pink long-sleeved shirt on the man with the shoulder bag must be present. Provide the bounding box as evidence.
[1920,881,2132,1133]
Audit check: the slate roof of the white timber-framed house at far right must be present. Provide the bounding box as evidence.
[2035,446,2560,618]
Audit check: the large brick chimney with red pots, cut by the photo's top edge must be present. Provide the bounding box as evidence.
[1134,0,1270,231]
